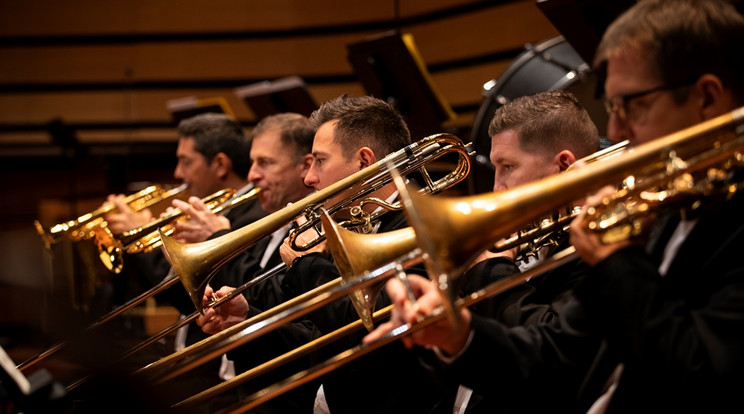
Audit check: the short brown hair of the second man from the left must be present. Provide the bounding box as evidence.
[250,113,315,162]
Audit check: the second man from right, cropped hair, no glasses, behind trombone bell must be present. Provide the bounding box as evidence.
[443,90,600,412]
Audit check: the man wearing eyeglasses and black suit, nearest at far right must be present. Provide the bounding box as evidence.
[366,0,744,414]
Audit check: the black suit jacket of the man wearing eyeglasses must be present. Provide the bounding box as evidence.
[438,195,744,413]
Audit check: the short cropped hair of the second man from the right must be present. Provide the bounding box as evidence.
[488,90,599,158]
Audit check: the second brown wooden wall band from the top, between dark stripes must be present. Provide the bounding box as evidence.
[0,2,558,84]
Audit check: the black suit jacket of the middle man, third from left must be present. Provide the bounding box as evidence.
[282,212,441,413]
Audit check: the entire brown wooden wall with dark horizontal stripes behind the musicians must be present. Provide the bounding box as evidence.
[0,0,584,233]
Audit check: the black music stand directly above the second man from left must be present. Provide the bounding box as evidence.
[235,76,318,120]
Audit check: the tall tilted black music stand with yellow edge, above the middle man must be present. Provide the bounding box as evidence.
[347,31,455,141]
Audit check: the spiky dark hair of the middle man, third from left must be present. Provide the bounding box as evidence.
[310,95,411,159]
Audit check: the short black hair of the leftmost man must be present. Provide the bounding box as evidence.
[178,113,251,177]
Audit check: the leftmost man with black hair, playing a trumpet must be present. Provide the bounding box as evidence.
[98,113,266,410]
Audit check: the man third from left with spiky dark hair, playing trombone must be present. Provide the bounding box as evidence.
[198,96,448,412]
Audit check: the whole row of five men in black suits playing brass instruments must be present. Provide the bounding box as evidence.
[78,0,744,413]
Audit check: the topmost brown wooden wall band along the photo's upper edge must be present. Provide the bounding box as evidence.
[0,0,402,36]
